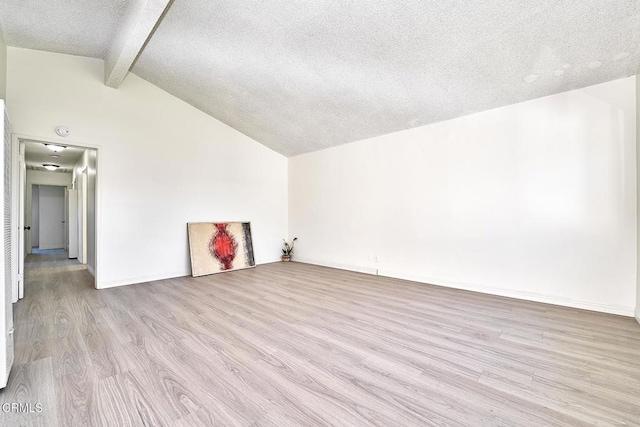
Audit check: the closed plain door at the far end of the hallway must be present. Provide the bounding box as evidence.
[39,185,65,249]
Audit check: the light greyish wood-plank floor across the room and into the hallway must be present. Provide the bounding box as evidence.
[0,261,640,427]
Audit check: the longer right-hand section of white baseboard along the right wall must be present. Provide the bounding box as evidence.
[379,271,633,317]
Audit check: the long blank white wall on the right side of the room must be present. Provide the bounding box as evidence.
[289,77,636,315]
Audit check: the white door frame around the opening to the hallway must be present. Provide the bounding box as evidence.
[11,133,102,302]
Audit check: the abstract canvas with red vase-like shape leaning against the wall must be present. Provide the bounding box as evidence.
[187,222,256,277]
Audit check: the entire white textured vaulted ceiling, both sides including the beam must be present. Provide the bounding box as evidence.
[0,0,640,156]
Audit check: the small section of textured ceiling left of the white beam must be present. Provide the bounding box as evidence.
[0,0,128,59]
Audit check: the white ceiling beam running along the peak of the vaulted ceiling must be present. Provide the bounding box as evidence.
[104,0,171,89]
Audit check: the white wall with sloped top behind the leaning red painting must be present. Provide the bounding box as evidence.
[7,47,287,287]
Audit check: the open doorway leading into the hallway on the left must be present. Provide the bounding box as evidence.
[14,136,98,299]
